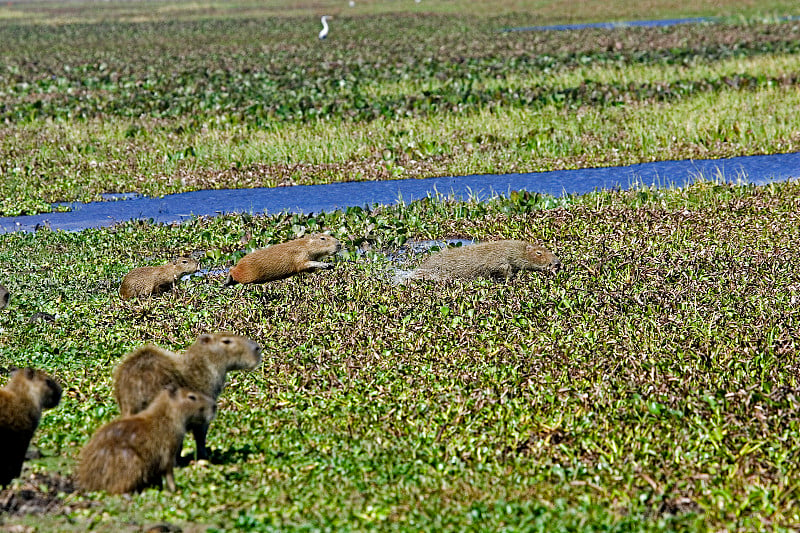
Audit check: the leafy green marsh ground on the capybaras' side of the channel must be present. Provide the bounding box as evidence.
[0,182,800,531]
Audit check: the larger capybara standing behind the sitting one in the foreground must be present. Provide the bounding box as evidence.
[114,333,261,459]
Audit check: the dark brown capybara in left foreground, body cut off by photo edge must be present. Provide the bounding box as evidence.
[0,368,61,486]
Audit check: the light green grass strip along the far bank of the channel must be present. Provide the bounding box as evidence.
[0,80,800,214]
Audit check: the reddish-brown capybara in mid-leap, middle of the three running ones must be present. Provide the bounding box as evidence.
[225,233,342,286]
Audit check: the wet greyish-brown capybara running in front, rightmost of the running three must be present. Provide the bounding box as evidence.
[410,240,561,281]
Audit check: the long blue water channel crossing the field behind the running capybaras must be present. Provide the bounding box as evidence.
[0,153,800,233]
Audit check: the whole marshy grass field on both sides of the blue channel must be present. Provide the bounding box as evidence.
[0,0,800,532]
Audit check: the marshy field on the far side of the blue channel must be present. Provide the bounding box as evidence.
[0,2,800,215]
